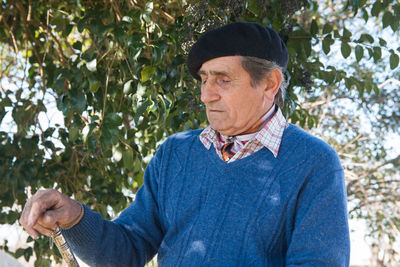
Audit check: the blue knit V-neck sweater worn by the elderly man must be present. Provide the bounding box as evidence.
[63,125,350,267]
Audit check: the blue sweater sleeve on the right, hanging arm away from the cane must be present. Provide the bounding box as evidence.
[286,151,350,267]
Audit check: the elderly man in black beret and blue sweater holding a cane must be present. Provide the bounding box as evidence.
[20,23,349,266]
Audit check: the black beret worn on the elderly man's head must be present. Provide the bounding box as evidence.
[187,22,289,80]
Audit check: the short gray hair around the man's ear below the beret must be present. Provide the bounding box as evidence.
[242,56,287,108]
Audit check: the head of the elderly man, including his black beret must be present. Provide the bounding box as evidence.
[188,22,288,135]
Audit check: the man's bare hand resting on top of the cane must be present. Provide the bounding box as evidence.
[19,189,82,239]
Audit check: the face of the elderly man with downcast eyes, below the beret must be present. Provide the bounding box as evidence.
[199,56,273,136]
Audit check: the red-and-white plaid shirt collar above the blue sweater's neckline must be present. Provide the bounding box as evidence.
[200,108,287,163]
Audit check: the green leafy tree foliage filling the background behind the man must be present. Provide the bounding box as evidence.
[0,0,400,265]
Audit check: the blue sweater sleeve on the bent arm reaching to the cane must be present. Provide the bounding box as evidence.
[63,148,163,266]
